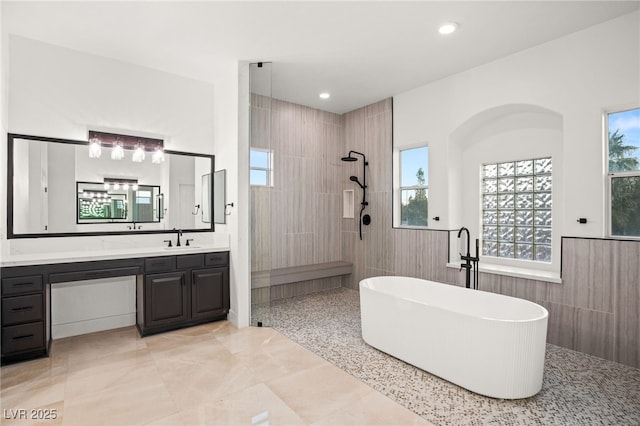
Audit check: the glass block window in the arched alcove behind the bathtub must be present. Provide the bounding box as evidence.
[482,158,552,262]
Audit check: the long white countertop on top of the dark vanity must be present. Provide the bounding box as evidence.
[0,245,229,268]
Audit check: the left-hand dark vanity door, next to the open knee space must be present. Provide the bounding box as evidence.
[144,272,189,327]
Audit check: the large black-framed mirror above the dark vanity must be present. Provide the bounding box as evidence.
[7,133,215,238]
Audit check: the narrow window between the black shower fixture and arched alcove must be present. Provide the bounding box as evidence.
[394,145,429,228]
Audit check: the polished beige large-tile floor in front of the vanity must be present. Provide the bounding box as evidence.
[0,321,430,426]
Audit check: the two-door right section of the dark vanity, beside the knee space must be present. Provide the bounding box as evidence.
[138,252,229,336]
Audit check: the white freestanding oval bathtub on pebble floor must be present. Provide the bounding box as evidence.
[360,276,549,399]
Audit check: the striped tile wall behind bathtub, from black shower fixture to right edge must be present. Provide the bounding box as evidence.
[342,100,640,368]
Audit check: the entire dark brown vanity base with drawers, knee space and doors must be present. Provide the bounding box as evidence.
[0,251,229,364]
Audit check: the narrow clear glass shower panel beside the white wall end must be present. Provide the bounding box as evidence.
[249,62,273,327]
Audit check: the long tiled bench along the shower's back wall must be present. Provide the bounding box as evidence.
[251,261,353,303]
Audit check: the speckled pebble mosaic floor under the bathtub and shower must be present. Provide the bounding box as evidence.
[270,288,640,426]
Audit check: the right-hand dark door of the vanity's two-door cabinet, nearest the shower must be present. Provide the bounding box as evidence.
[191,268,229,319]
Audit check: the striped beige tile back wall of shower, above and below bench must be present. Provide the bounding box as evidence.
[251,94,346,298]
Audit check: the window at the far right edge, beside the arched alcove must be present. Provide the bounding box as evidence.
[606,108,640,238]
